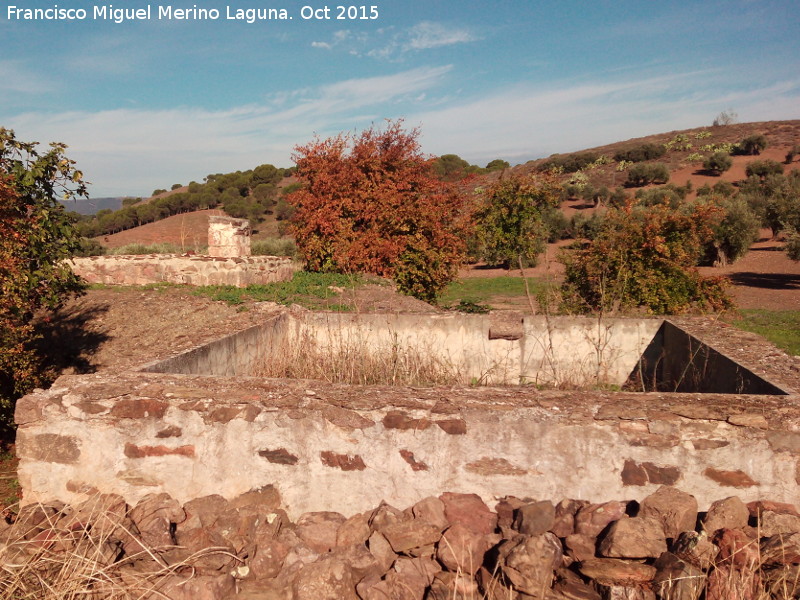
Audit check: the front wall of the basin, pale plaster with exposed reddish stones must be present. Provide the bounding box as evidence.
[16,372,800,516]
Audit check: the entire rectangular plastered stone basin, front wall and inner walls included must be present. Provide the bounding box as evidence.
[16,308,800,518]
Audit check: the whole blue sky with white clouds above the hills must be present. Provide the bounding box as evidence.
[0,0,800,197]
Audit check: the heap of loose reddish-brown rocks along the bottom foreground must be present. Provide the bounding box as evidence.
[0,486,800,600]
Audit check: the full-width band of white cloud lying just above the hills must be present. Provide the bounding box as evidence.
[6,63,800,197]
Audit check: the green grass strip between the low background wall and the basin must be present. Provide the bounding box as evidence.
[194,271,366,311]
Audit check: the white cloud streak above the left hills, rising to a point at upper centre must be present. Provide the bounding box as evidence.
[0,66,451,197]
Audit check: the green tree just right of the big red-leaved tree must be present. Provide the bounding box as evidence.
[475,174,560,269]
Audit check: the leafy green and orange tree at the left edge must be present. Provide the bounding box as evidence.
[0,128,87,427]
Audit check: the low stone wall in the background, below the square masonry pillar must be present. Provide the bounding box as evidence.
[71,254,296,287]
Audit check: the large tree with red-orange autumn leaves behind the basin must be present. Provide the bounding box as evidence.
[290,121,470,301]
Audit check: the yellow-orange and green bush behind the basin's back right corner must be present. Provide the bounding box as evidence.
[562,205,731,314]
